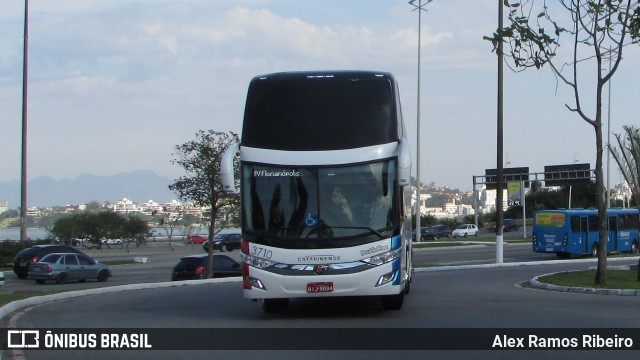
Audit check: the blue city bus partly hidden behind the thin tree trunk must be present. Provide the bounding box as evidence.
[533,208,640,258]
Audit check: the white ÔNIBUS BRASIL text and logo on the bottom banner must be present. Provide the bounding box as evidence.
[7,330,152,349]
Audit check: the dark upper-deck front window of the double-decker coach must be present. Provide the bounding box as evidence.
[241,71,404,151]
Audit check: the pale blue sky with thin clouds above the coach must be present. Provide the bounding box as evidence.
[0,0,640,191]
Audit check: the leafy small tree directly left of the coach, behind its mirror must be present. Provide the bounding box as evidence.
[169,130,239,278]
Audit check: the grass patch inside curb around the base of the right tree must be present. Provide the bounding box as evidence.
[538,266,640,290]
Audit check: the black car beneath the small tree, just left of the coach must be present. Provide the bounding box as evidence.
[171,254,242,281]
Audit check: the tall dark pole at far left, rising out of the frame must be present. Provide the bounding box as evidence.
[20,0,29,241]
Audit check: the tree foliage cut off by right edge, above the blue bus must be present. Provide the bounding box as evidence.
[611,126,640,206]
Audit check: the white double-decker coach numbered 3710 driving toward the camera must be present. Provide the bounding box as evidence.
[221,71,413,312]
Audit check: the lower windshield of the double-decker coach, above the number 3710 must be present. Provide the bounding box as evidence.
[242,159,399,245]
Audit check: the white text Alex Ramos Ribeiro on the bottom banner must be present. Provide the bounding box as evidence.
[491,334,633,350]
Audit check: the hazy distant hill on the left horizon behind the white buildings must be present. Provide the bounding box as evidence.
[0,170,177,209]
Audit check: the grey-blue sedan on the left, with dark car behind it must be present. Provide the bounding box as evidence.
[27,253,111,284]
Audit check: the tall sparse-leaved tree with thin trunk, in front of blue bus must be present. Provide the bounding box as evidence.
[484,0,640,286]
